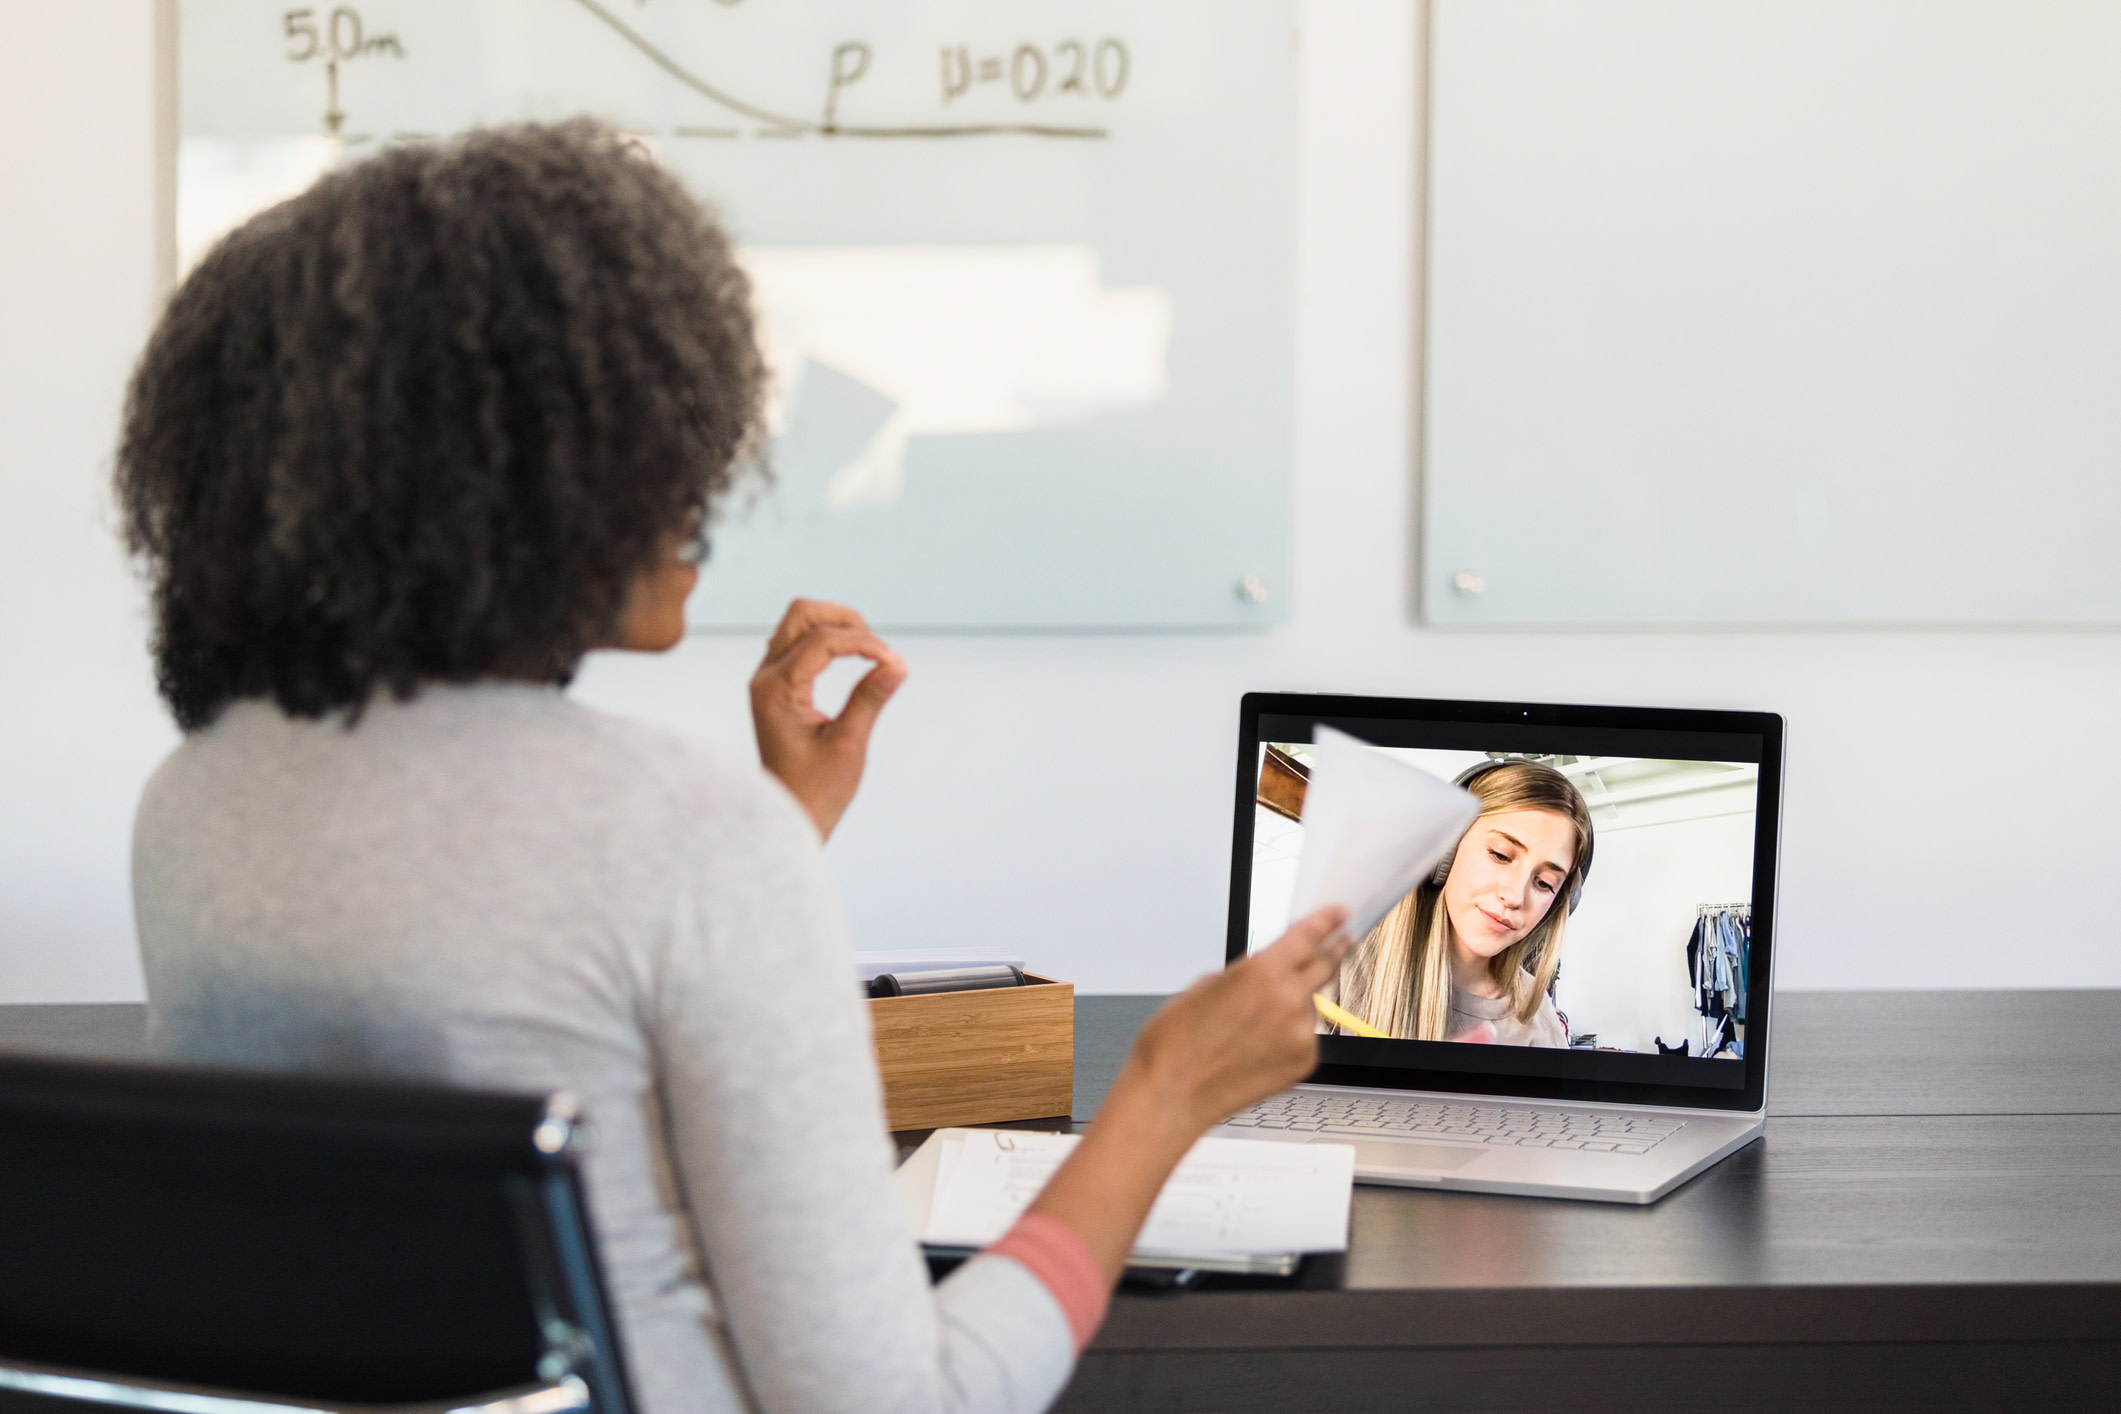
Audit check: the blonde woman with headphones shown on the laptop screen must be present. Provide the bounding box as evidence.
[1338,761,1593,1047]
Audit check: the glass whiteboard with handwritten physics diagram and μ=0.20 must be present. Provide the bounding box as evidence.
[178,0,1296,630]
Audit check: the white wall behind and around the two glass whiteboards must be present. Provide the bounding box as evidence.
[0,0,2121,1001]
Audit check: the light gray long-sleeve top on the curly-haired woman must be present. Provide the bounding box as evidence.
[134,685,1073,1414]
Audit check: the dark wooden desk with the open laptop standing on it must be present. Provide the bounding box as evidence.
[1061,992,2121,1412]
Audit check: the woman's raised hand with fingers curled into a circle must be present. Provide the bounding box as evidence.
[751,600,906,837]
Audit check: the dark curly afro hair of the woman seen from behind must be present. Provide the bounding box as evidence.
[117,121,766,731]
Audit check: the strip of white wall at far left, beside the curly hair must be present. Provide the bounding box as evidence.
[0,0,176,1001]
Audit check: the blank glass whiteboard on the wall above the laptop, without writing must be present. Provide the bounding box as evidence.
[1421,0,2121,623]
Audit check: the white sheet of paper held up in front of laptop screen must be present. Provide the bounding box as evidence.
[1290,727,1480,937]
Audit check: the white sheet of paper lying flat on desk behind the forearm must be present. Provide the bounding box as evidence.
[921,1130,1355,1255]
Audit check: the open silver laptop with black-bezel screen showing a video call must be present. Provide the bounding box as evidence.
[1211,693,1782,1204]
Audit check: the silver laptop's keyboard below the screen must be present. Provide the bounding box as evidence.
[1224,1090,1686,1153]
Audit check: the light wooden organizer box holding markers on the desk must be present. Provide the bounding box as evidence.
[870,973,1075,1130]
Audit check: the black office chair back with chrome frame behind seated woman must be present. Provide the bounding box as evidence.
[0,1058,632,1414]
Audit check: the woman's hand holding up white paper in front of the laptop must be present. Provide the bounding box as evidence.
[1126,907,1349,1132]
